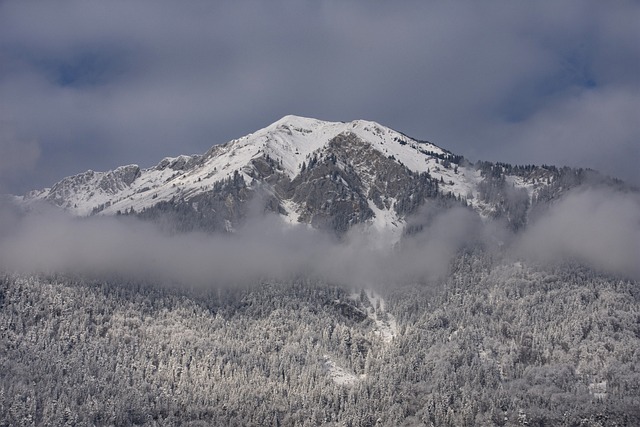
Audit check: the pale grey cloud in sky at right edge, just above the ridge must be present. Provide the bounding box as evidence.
[506,88,640,185]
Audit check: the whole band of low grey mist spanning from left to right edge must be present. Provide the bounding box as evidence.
[0,186,640,286]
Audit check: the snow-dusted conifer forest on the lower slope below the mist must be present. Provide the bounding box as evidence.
[0,249,640,426]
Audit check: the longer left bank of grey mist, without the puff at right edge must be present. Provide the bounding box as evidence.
[0,202,474,286]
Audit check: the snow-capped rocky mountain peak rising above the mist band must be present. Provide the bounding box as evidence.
[21,116,616,234]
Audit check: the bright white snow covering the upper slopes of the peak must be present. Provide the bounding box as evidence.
[22,116,552,235]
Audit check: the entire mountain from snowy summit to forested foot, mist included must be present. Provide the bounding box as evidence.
[0,116,640,426]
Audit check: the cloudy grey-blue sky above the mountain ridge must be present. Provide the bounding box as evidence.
[0,0,640,193]
